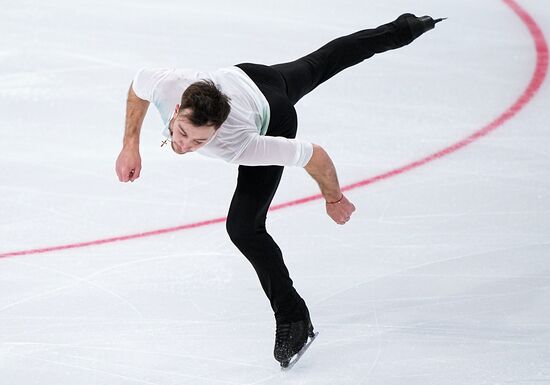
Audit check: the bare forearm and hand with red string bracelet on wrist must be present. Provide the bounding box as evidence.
[305,144,355,225]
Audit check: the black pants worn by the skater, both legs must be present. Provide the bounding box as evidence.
[227,15,418,322]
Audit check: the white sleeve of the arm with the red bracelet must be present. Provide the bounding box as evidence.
[232,134,313,167]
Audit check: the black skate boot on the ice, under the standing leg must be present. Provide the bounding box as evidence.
[273,317,315,368]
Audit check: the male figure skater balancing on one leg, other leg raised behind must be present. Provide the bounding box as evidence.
[116,14,441,367]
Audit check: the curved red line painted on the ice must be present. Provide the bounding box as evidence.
[0,0,548,258]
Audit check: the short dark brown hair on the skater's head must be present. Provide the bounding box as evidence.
[180,80,231,129]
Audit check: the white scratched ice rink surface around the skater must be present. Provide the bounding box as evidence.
[0,0,550,385]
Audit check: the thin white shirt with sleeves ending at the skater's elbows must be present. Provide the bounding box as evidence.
[132,67,313,167]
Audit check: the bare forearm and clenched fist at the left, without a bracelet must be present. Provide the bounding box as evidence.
[116,86,149,182]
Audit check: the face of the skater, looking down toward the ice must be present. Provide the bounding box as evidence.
[163,104,216,154]
